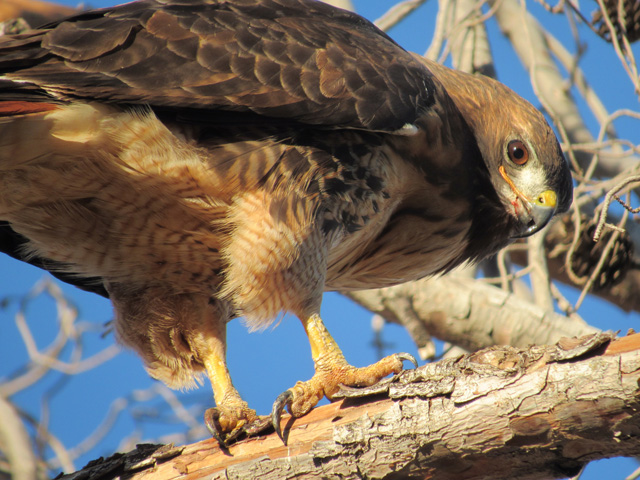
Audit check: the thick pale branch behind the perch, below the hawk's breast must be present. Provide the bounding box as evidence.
[346,275,597,351]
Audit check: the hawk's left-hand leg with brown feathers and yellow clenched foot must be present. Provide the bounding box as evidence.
[108,285,269,446]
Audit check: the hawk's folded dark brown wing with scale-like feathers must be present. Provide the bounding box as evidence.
[0,0,434,132]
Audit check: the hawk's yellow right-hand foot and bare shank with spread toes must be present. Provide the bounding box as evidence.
[271,315,418,444]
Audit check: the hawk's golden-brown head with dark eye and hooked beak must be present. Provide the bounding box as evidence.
[429,60,573,239]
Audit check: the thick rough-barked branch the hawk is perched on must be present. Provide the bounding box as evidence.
[60,333,640,480]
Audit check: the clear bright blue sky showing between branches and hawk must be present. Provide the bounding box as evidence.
[0,0,640,480]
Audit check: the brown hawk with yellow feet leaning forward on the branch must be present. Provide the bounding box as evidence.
[0,0,572,441]
